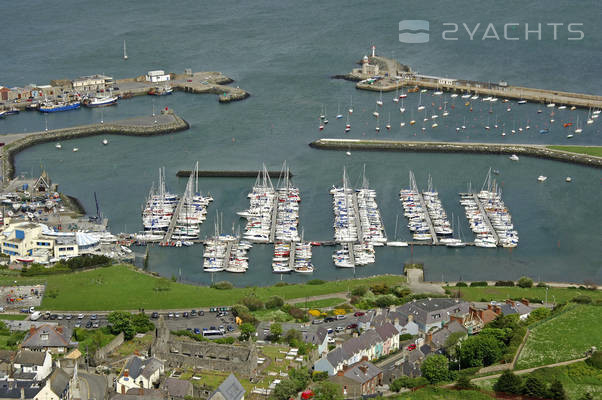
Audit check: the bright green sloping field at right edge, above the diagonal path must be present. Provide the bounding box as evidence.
[516,306,602,369]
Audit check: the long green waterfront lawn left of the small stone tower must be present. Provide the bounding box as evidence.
[0,265,405,311]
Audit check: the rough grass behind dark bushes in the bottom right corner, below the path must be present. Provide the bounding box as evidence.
[476,361,602,400]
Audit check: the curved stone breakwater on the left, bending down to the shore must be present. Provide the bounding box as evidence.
[0,112,190,182]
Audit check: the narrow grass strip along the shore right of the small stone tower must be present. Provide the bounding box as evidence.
[448,286,602,303]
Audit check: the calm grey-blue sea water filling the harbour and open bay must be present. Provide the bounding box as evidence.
[0,1,602,286]
